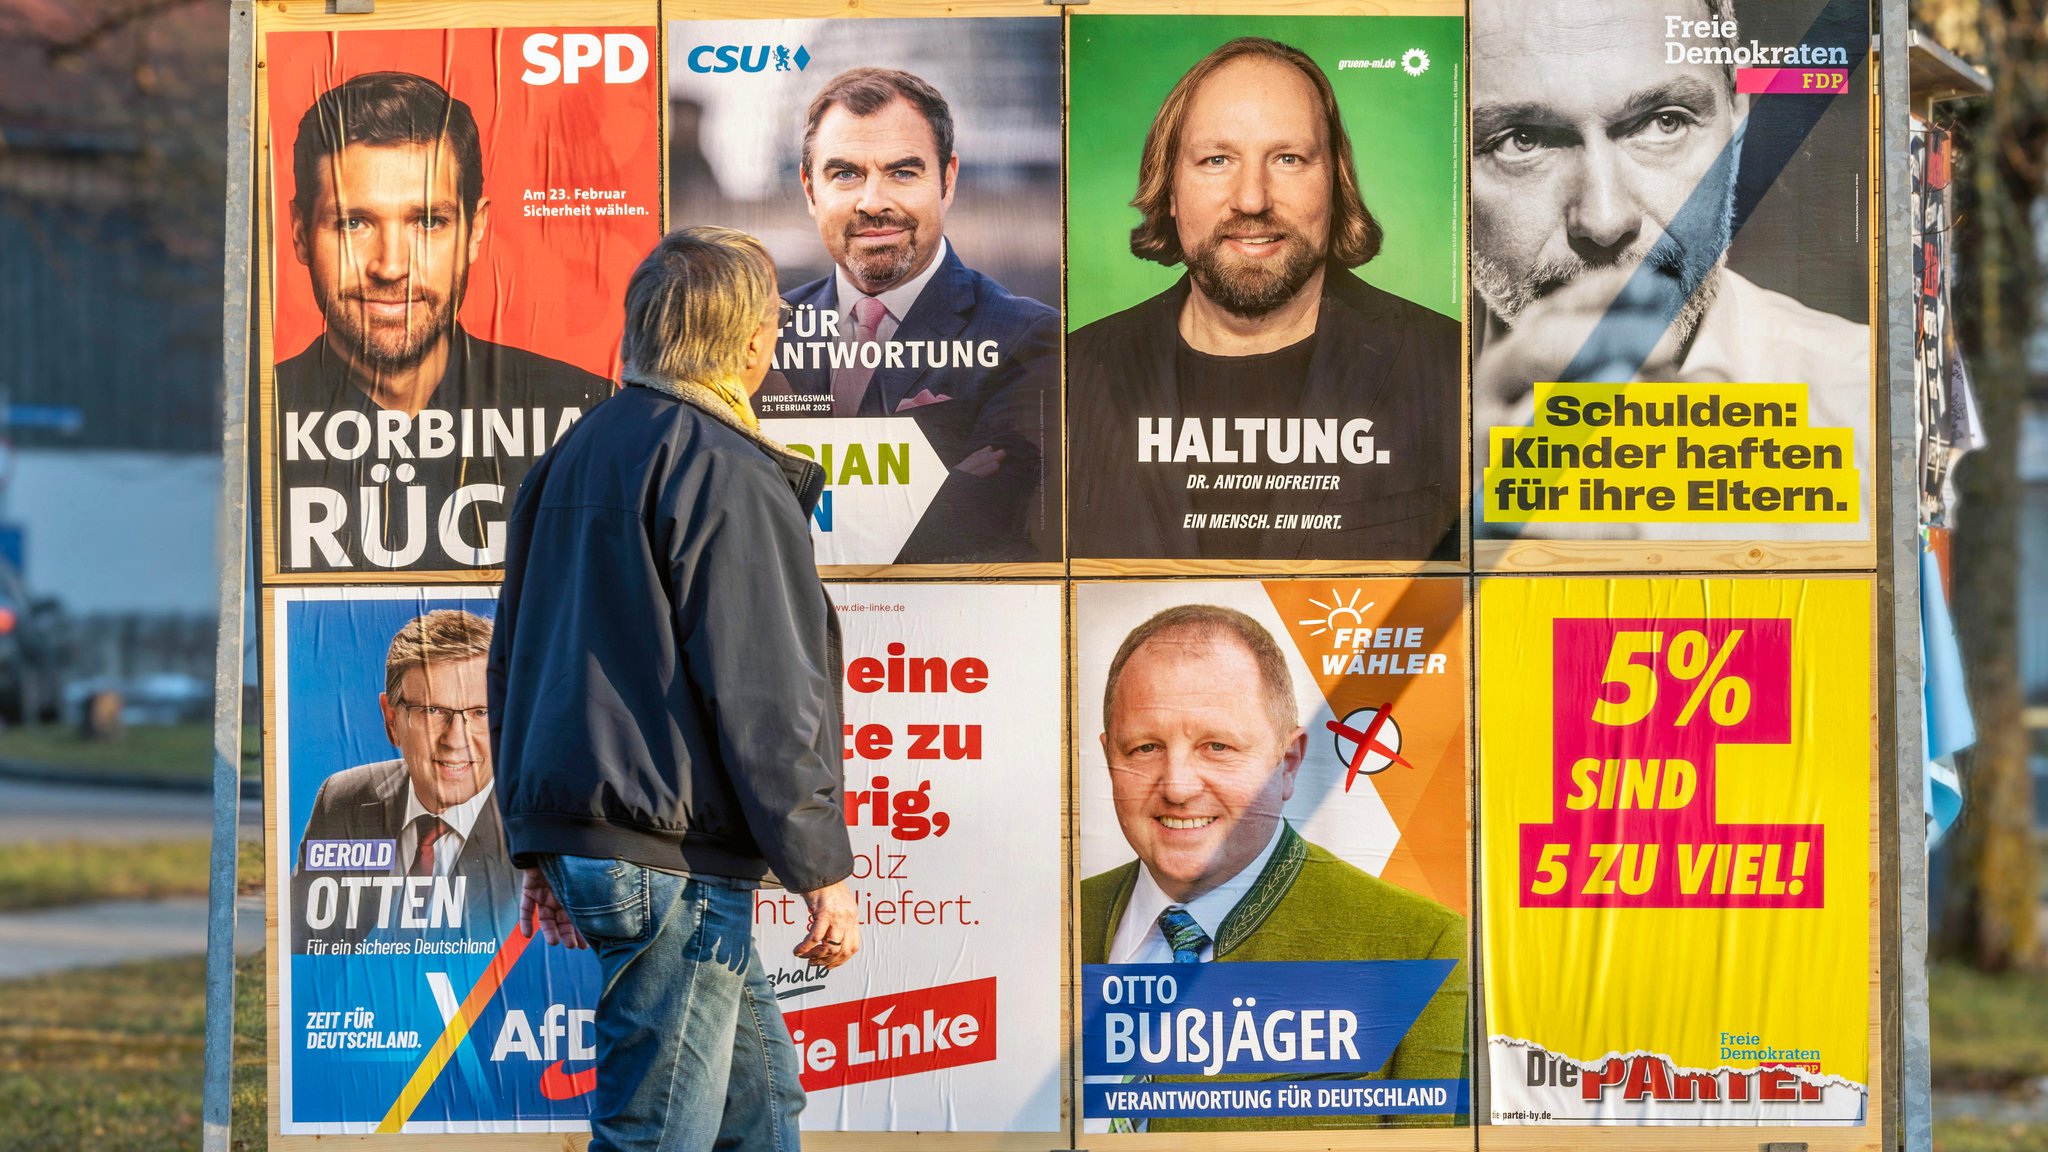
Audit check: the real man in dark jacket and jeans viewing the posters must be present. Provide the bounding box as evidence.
[489,228,860,1152]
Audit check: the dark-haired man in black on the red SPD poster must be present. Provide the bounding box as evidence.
[276,72,612,572]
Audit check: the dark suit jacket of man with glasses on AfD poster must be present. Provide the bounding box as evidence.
[291,760,518,951]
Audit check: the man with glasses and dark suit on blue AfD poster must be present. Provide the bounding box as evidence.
[291,609,518,951]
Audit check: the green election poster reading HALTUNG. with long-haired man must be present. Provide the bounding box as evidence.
[1067,10,1464,574]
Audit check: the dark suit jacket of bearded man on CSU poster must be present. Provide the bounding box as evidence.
[762,246,1059,564]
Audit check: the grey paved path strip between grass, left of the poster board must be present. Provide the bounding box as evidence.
[0,896,262,980]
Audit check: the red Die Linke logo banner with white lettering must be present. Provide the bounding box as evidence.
[782,976,995,1093]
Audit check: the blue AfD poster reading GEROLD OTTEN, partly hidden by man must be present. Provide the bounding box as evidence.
[268,586,598,1136]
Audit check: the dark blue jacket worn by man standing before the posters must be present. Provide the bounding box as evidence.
[489,387,852,892]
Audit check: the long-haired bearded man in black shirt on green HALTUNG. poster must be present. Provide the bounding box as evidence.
[1069,37,1460,560]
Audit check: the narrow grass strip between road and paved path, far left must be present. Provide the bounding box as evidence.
[0,828,262,910]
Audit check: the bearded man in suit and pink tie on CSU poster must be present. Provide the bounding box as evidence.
[760,68,1059,564]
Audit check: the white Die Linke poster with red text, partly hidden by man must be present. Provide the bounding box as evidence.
[754,584,1063,1136]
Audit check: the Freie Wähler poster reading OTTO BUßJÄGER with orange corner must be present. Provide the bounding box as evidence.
[1073,580,1470,1123]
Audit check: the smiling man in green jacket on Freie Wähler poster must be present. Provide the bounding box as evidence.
[1079,605,1466,1132]
